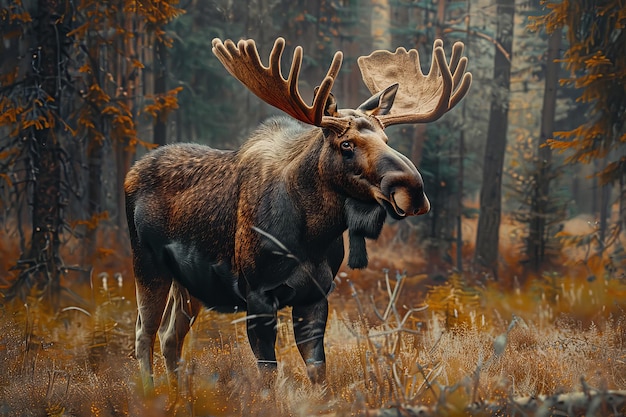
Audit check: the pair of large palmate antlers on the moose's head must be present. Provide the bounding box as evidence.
[213,38,472,128]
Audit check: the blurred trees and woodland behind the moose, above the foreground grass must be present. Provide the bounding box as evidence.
[0,0,626,303]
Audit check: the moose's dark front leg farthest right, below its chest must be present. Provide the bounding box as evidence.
[291,298,328,384]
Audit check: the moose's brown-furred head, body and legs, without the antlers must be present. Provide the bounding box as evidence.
[125,90,428,386]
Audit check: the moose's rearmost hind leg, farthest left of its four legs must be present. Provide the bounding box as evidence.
[135,273,171,393]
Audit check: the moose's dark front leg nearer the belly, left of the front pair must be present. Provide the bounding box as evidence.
[247,292,278,372]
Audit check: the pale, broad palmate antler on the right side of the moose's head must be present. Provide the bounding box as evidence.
[358,39,472,127]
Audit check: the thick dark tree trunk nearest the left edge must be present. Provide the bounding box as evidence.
[1,0,69,305]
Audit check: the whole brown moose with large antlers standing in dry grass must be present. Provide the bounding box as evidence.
[124,38,471,389]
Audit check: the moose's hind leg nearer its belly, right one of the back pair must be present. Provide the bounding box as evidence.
[159,281,201,390]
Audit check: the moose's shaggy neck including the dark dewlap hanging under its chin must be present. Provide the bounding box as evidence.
[239,117,386,268]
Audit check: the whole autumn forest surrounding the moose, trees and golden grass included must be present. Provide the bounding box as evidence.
[0,0,626,416]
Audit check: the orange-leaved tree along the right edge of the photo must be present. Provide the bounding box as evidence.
[533,0,626,248]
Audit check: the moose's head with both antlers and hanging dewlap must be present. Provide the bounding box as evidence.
[213,38,472,268]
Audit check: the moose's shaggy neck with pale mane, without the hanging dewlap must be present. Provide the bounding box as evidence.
[238,117,346,254]
